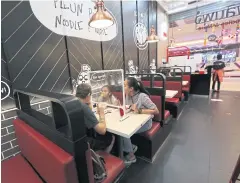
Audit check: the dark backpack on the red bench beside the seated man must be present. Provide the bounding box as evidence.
[91,149,107,182]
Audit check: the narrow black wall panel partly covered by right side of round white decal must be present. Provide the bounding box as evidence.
[137,1,149,70]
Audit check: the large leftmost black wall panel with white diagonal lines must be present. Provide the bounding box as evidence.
[1,1,71,105]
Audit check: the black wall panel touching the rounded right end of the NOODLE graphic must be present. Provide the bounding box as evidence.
[102,0,123,70]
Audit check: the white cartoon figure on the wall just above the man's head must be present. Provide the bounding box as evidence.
[72,64,91,93]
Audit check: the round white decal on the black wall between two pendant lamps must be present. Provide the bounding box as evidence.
[133,23,148,50]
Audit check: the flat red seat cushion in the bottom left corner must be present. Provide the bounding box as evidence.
[2,154,43,183]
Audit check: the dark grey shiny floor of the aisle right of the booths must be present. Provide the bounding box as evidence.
[120,91,240,183]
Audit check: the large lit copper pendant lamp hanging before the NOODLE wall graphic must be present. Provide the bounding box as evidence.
[88,0,114,29]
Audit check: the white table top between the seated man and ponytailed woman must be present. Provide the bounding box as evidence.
[94,109,153,138]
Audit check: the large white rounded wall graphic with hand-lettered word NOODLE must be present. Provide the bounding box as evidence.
[30,0,118,41]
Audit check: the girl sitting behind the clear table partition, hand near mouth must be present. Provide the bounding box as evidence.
[98,85,120,106]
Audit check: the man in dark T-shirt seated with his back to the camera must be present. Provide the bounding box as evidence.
[76,83,115,153]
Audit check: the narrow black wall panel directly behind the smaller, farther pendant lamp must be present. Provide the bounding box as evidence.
[148,1,158,66]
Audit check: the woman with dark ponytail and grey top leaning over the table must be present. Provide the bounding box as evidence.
[123,77,159,164]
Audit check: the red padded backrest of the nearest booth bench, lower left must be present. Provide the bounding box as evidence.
[2,119,78,183]
